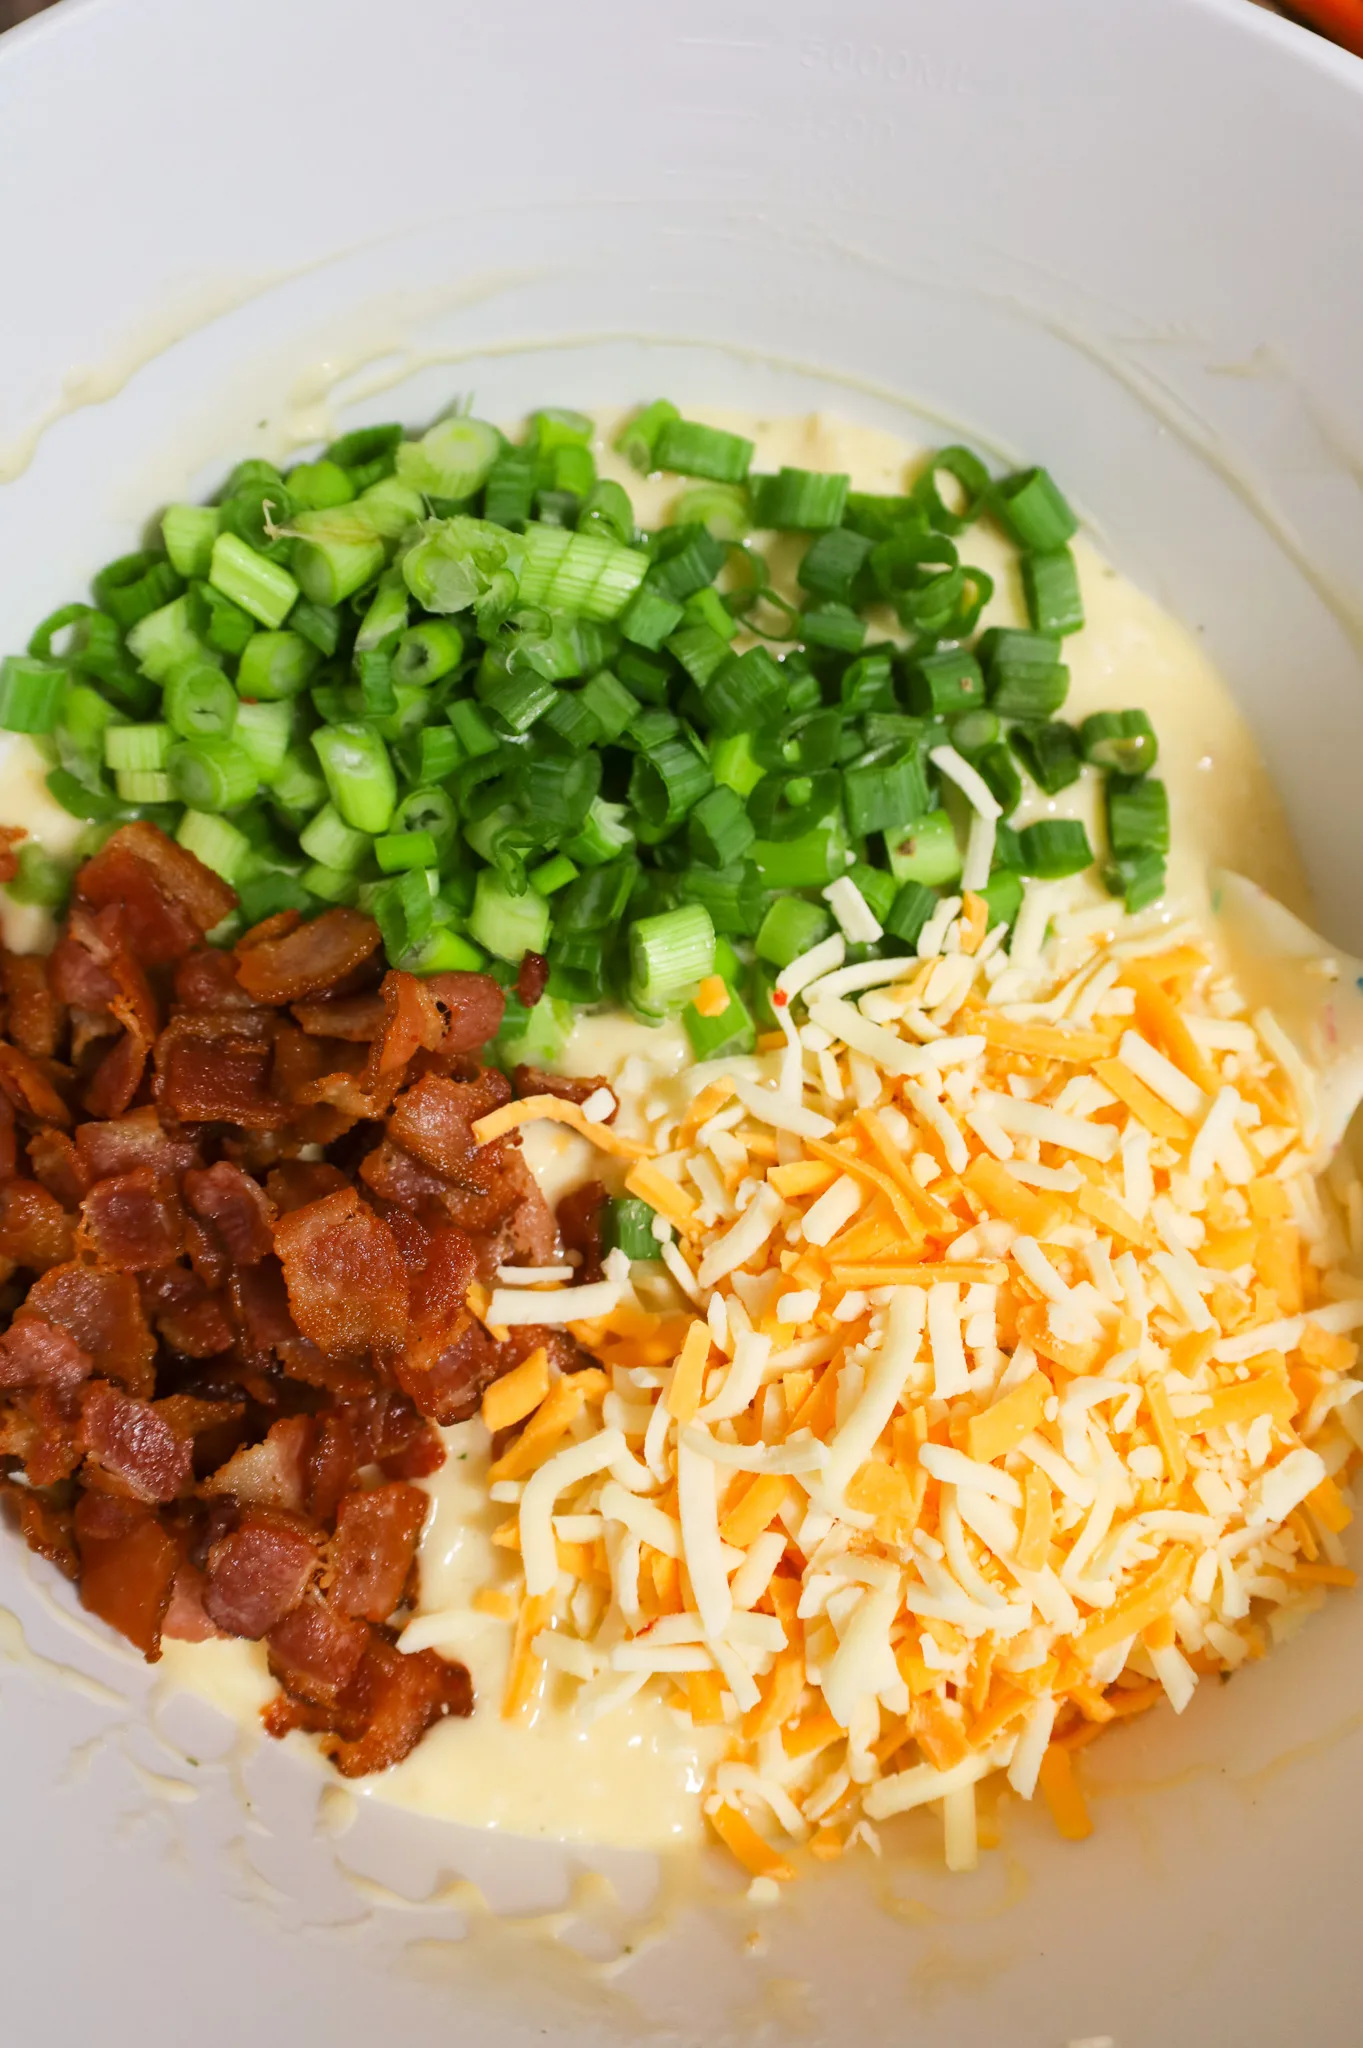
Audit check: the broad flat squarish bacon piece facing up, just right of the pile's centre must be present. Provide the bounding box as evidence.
[274,1188,407,1358]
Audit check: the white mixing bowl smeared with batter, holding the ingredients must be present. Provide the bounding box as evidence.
[0,0,1363,2048]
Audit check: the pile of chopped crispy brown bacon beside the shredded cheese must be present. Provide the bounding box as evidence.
[0,823,523,1776]
